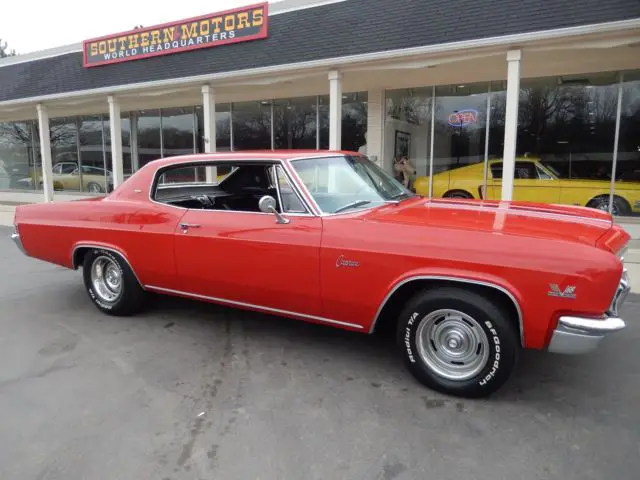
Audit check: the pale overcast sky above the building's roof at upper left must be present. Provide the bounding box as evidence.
[0,0,280,53]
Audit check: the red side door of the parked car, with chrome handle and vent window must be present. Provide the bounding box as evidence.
[175,166,322,316]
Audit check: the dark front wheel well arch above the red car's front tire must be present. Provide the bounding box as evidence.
[372,279,522,342]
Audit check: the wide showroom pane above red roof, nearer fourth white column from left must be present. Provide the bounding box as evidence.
[273,97,318,150]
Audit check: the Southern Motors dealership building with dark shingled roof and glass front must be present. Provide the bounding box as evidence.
[0,0,640,217]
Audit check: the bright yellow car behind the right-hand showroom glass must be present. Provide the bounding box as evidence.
[414,158,640,215]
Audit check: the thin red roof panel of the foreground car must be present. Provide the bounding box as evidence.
[142,150,360,167]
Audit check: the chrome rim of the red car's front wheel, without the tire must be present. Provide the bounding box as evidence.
[416,309,490,381]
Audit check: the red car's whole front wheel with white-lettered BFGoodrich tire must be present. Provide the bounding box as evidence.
[397,287,520,398]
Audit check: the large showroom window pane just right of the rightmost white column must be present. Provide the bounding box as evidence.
[516,73,619,210]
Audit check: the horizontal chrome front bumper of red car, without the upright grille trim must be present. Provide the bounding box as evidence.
[548,317,626,355]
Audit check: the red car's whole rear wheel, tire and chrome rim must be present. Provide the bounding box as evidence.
[82,248,145,316]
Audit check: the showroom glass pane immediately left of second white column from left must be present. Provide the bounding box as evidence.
[78,115,113,194]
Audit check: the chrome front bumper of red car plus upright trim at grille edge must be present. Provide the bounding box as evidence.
[548,269,631,355]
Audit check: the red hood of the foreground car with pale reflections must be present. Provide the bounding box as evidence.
[366,198,613,246]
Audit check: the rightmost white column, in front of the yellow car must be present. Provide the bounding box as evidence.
[501,50,522,200]
